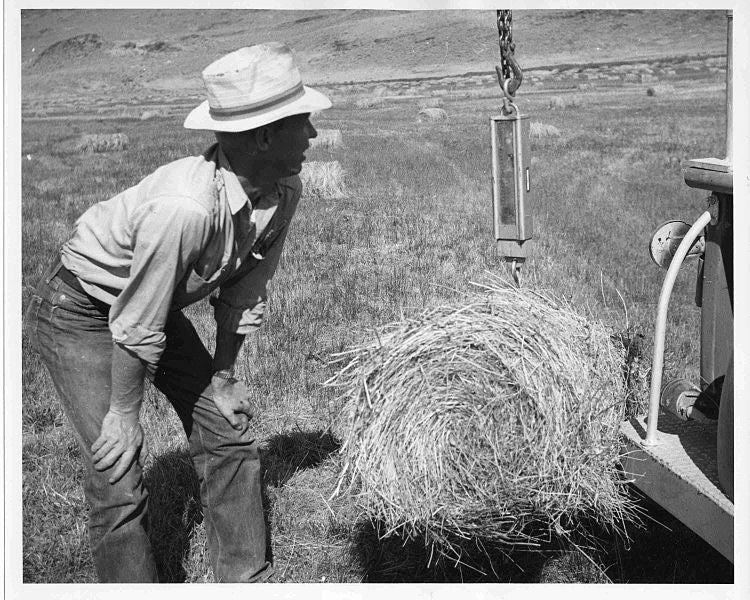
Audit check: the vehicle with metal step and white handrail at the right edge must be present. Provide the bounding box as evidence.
[622,11,734,562]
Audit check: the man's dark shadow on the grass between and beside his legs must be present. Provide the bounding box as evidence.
[145,430,341,583]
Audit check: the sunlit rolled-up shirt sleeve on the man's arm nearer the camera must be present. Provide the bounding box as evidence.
[109,196,210,366]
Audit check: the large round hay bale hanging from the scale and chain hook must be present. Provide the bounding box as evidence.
[328,282,635,556]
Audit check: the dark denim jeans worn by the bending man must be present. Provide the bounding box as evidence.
[26,265,272,582]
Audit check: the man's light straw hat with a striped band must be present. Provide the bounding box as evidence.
[185,42,331,131]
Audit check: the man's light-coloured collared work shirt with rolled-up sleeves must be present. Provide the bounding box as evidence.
[61,145,302,365]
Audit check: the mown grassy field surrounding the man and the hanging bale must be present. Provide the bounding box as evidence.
[22,77,733,583]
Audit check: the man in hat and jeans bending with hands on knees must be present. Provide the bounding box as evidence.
[27,43,331,582]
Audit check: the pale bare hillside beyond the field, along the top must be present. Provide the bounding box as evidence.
[21,9,726,100]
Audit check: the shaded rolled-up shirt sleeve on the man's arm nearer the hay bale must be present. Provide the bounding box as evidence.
[210,178,302,335]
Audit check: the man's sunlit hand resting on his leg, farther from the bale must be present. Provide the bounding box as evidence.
[91,409,146,483]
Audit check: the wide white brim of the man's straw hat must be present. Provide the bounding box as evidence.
[183,86,331,131]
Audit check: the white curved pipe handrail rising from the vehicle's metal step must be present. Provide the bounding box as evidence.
[643,211,711,446]
